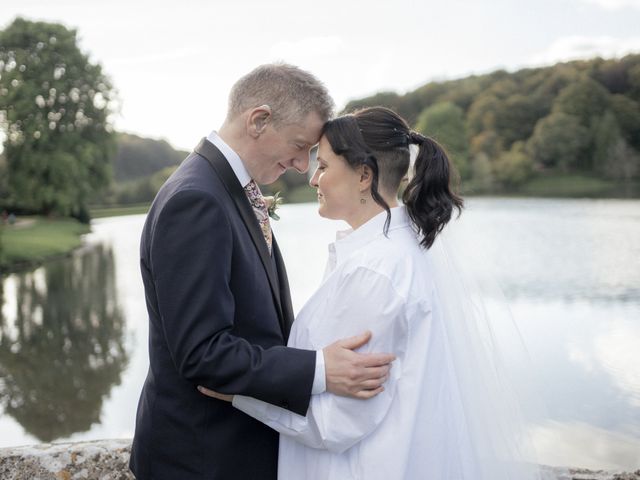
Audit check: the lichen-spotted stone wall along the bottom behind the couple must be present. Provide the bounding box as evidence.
[0,440,640,480]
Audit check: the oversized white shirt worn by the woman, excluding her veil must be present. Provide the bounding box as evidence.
[233,207,492,480]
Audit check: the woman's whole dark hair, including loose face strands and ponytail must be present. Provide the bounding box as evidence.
[322,107,463,248]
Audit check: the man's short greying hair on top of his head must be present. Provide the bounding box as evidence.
[227,63,334,125]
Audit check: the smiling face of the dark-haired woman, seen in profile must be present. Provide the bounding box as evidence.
[309,136,361,224]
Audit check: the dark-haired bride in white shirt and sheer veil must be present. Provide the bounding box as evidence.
[201,107,552,480]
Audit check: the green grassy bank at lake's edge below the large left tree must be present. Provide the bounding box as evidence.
[0,217,90,271]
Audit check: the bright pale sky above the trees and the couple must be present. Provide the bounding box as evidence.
[0,0,640,150]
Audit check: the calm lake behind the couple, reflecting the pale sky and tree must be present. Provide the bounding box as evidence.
[0,198,640,470]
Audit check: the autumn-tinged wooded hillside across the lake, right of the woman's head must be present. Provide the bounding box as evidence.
[345,55,640,192]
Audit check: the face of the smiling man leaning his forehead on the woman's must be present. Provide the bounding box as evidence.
[244,112,323,184]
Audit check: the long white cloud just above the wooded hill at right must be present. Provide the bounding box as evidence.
[530,35,640,65]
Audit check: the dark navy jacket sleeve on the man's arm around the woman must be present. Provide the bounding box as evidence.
[149,190,316,415]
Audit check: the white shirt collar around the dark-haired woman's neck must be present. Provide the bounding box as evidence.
[329,205,410,267]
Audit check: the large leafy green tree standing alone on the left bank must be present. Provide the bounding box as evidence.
[0,18,114,220]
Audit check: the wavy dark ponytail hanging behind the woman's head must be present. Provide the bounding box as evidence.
[402,131,464,248]
